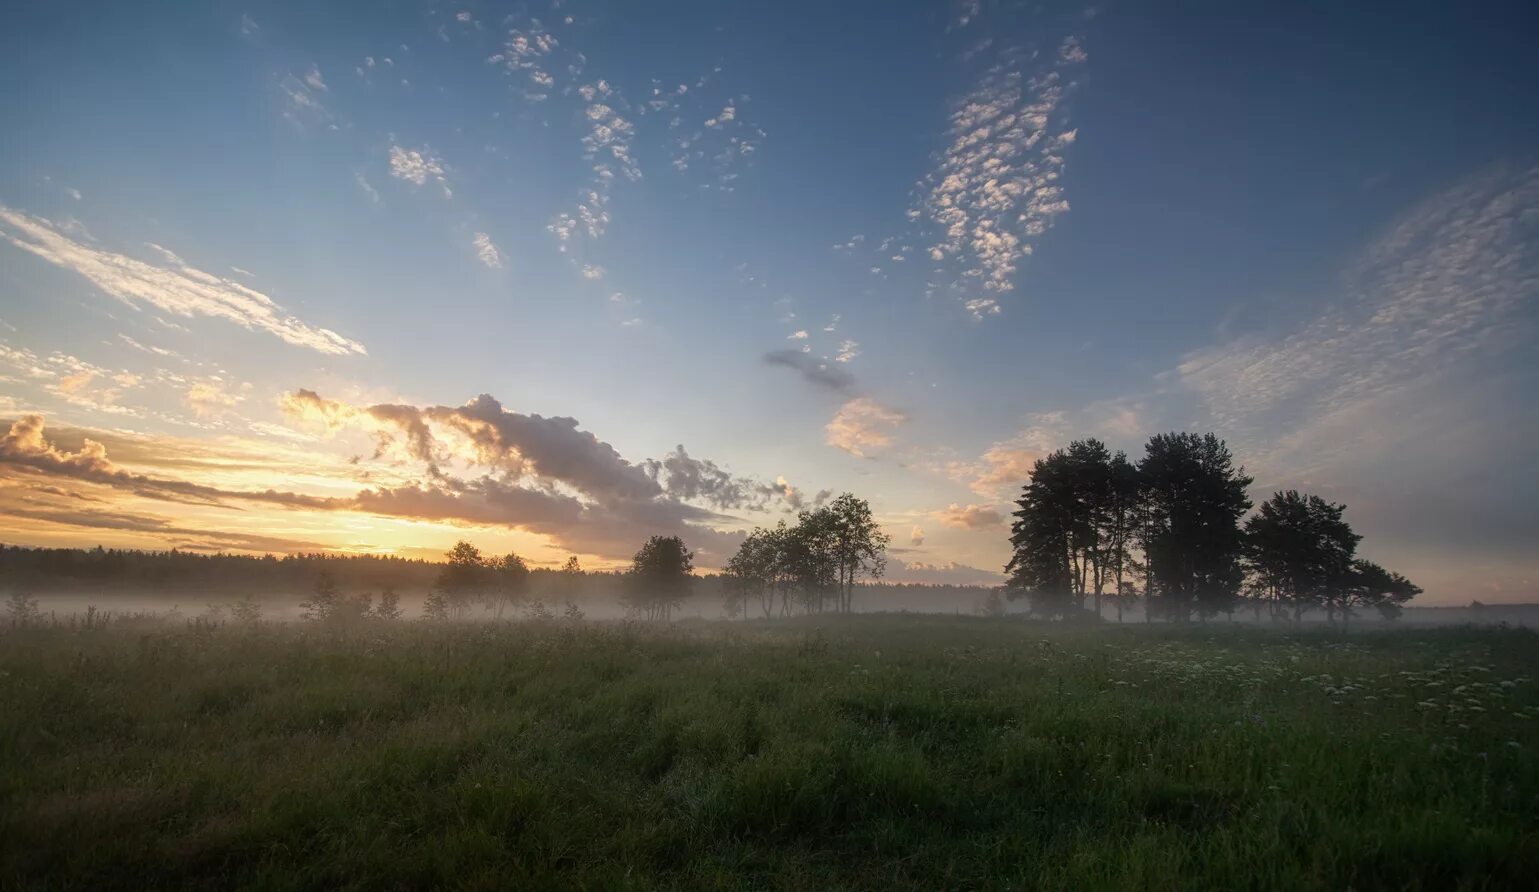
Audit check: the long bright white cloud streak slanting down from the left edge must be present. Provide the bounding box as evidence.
[0,206,366,355]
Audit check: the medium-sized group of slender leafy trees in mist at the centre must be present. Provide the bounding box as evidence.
[723,492,891,617]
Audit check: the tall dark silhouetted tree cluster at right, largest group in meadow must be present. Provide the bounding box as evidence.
[1005,434,1420,623]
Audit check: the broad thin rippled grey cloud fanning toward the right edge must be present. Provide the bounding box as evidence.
[1174,166,1539,461]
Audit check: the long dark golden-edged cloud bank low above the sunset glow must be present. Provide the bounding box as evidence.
[0,412,742,566]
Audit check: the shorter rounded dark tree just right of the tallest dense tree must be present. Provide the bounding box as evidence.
[1245,489,1362,621]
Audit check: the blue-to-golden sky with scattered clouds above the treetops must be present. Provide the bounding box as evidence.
[0,0,1539,604]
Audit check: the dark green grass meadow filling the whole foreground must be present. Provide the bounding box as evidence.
[0,615,1539,889]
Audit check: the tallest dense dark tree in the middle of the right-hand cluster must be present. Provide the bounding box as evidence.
[1137,434,1251,621]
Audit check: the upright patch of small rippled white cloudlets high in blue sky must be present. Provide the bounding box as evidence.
[920,37,1085,318]
